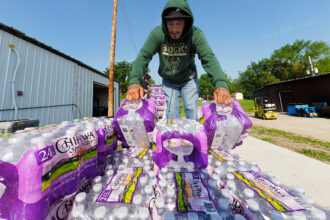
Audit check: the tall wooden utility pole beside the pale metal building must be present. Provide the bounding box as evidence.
[108,0,117,117]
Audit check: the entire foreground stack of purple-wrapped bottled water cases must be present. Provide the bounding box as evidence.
[0,101,330,220]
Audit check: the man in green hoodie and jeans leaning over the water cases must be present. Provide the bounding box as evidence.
[126,0,231,120]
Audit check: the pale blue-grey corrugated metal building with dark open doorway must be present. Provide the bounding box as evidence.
[0,23,119,126]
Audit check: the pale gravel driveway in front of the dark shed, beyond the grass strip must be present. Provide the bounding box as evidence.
[249,113,330,142]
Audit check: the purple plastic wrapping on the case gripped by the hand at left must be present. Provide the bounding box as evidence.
[113,99,155,148]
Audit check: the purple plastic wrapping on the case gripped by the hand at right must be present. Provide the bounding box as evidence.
[202,100,252,149]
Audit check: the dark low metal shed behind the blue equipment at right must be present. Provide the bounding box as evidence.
[253,73,330,112]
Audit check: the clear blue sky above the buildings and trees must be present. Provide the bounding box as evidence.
[0,0,330,83]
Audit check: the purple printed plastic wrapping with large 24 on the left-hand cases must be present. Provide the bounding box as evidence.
[0,124,104,220]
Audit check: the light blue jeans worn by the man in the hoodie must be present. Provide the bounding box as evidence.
[163,78,199,120]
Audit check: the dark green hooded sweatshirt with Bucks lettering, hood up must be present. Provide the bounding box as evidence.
[129,0,228,88]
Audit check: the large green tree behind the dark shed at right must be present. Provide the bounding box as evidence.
[235,40,330,97]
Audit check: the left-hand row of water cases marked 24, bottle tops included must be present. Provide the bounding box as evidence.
[0,118,117,219]
